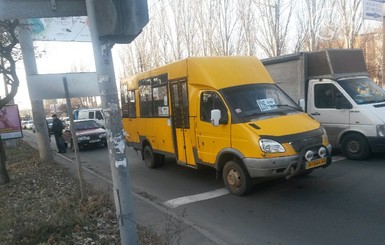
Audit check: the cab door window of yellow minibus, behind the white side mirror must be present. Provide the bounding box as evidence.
[200,92,228,124]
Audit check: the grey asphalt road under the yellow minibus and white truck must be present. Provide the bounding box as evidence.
[25,132,385,245]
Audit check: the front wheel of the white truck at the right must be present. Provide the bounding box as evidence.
[341,133,370,160]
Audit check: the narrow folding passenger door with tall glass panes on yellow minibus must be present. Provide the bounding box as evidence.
[170,80,195,165]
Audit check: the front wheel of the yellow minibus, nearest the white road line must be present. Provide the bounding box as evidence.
[223,161,251,196]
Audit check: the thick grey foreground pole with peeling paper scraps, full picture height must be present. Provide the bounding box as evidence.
[86,0,138,244]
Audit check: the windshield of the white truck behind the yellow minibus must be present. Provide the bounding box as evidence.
[338,77,385,105]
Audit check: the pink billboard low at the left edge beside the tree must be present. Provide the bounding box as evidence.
[0,105,23,140]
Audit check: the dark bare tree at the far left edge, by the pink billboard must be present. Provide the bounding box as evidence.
[0,20,19,184]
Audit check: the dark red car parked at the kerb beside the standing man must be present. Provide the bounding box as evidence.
[63,119,107,149]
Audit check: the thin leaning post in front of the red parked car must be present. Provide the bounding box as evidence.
[63,77,84,201]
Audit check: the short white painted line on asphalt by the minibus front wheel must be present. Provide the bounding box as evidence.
[163,188,230,208]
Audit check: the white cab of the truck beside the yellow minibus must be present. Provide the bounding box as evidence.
[307,76,385,160]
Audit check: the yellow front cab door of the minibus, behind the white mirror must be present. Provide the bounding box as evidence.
[196,91,231,164]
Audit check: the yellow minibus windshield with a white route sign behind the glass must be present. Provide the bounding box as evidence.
[222,84,301,121]
